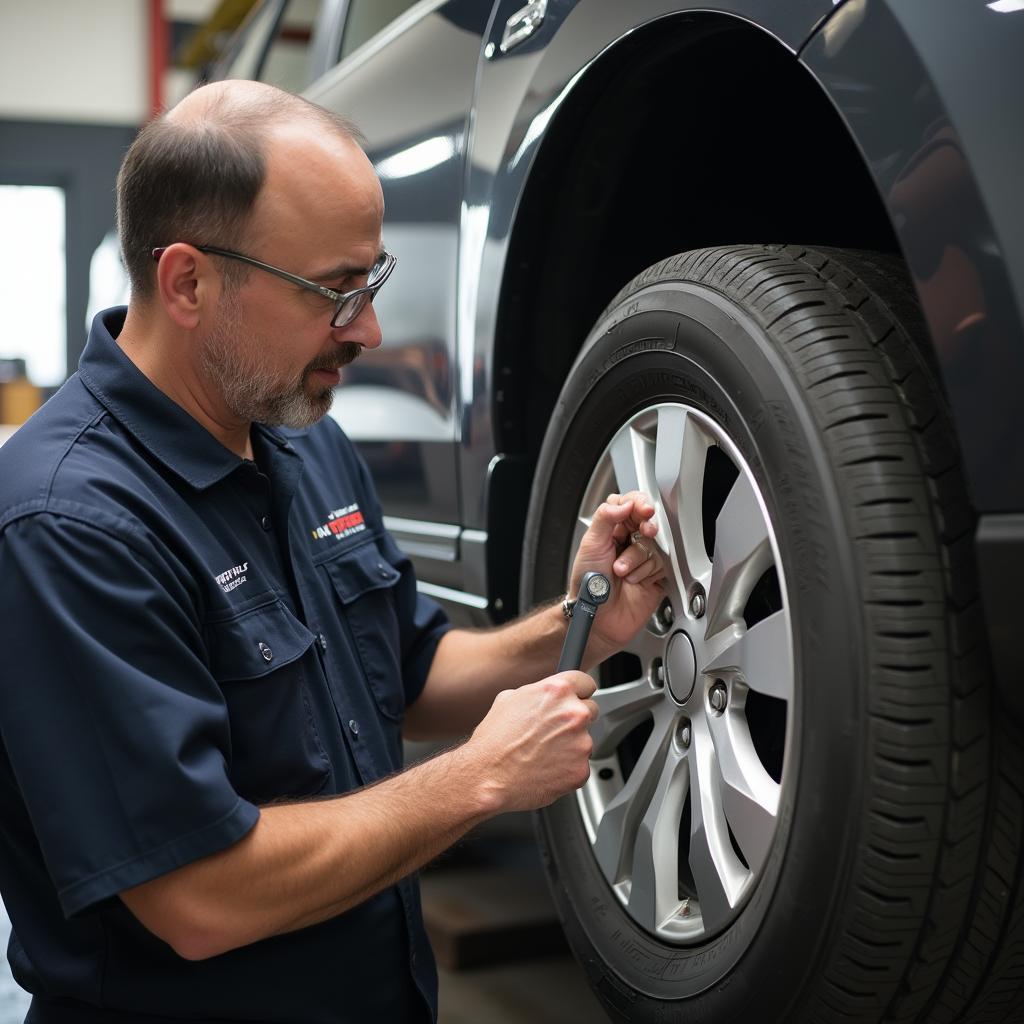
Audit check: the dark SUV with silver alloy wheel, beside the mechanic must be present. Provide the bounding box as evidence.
[220,0,1024,1024]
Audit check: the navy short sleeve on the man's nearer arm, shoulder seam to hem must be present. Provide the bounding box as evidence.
[0,513,259,916]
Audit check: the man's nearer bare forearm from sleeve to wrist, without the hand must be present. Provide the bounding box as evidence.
[122,748,499,959]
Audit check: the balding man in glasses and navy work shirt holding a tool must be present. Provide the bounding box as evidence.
[0,82,664,1024]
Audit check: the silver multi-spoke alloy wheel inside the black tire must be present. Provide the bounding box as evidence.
[572,402,795,943]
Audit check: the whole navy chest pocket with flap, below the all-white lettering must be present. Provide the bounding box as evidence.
[206,600,330,803]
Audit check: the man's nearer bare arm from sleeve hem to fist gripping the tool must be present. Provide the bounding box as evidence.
[121,673,597,959]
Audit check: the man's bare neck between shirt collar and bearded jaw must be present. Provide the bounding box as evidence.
[117,306,253,459]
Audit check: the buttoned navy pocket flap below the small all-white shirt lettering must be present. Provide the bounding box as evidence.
[200,600,313,681]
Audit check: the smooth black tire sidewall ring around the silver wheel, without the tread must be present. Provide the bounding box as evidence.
[522,281,864,1021]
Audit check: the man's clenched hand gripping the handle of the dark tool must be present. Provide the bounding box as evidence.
[462,672,597,812]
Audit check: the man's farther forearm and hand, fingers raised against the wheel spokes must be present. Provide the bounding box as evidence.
[402,492,665,739]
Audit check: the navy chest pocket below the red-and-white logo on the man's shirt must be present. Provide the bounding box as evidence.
[323,541,406,722]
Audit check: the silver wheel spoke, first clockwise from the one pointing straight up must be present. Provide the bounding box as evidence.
[708,473,772,634]
